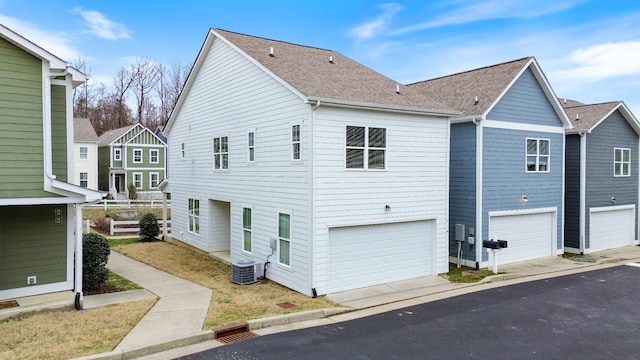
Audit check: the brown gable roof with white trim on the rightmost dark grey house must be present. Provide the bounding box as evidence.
[561,100,640,135]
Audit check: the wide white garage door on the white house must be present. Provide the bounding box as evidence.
[327,221,436,293]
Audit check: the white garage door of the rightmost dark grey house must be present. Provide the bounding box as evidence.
[589,207,636,252]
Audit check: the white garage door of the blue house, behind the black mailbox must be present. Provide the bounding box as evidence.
[489,212,557,264]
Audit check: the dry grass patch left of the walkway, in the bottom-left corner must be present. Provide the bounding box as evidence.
[0,300,156,360]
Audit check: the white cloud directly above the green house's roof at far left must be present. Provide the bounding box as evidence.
[0,14,83,61]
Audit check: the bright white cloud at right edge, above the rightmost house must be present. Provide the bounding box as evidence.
[554,41,640,81]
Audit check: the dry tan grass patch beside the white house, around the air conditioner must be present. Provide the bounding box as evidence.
[113,242,338,329]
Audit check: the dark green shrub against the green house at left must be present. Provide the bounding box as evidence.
[82,233,111,290]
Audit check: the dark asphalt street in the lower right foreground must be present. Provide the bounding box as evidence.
[180,265,640,360]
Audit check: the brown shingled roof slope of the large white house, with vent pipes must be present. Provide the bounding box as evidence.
[213,29,457,113]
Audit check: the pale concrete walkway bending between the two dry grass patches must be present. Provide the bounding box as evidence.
[96,252,212,353]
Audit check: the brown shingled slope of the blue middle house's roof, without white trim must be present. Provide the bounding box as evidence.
[408,57,533,116]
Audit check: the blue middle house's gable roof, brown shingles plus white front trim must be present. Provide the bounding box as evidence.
[409,56,571,127]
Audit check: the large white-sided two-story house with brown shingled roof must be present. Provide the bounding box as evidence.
[161,29,457,296]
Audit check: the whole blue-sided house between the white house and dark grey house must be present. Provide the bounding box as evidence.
[410,57,572,268]
